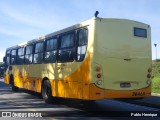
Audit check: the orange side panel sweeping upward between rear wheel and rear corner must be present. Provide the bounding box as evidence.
[50,55,90,99]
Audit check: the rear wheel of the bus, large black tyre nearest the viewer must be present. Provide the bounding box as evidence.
[42,80,52,103]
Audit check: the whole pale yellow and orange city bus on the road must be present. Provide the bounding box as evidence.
[4,17,152,102]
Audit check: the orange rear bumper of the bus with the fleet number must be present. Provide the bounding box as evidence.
[90,84,151,100]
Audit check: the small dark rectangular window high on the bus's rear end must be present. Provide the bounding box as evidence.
[134,27,147,38]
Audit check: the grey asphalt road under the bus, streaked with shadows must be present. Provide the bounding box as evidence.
[0,79,160,120]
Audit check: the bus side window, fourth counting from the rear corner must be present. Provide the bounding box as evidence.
[33,42,44,63]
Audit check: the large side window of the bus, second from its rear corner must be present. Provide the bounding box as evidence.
[58,32,75,62]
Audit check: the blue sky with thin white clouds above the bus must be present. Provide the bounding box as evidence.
[0,0,160,62]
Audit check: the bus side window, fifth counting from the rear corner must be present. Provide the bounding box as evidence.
[25,45,33,64]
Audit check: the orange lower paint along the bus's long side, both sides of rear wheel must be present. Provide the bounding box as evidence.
[6,55,90,99]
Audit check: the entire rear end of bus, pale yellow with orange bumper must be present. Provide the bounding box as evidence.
[92,19,151,98]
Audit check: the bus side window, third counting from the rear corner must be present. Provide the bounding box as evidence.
[44,38,57,63]
